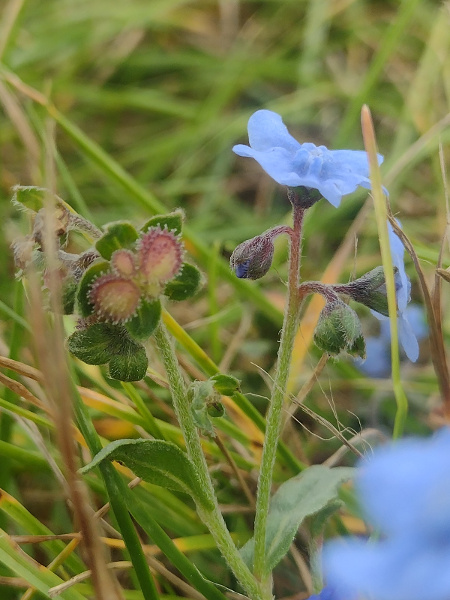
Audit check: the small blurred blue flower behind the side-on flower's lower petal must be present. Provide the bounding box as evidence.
[355,304,428,379]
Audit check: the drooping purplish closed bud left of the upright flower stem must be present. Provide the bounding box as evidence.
[230,232,274,279]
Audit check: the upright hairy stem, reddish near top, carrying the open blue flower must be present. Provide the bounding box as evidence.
[254,198,305,587]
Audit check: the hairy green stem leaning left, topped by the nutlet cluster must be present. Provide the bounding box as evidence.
[154,323,271,600]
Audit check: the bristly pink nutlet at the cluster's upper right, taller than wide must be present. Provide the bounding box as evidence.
[136,227,183,297]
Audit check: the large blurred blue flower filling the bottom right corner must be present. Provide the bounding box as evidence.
[323,427,450,600]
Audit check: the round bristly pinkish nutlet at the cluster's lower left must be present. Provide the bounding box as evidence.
[89,273,141,323]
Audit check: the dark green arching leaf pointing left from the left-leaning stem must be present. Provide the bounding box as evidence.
[81,439,212,510]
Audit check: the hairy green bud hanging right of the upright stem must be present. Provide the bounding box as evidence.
[314,300,366,358]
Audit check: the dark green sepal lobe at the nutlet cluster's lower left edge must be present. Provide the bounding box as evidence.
[67,323,126,365]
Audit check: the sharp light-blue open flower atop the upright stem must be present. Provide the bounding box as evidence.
[233,110,383,206]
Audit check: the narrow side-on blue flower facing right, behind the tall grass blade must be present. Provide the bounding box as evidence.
[372,221,419,362]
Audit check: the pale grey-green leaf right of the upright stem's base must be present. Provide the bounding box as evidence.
[241,465,354,575]
